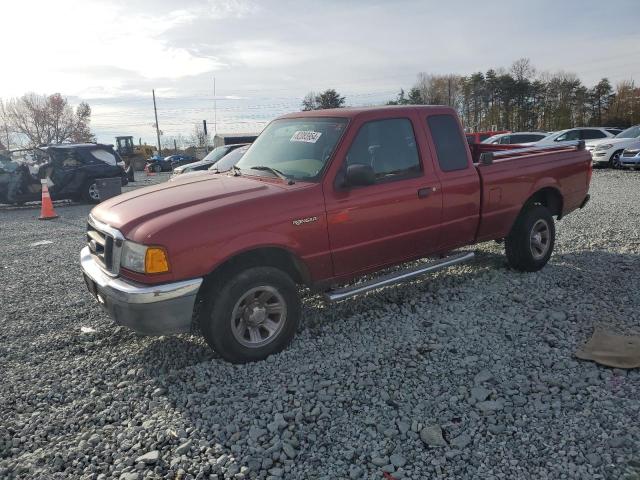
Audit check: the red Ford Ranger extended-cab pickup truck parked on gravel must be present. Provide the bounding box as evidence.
[81,106,591,362]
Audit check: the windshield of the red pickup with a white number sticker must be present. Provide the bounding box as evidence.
[237,117,347,181]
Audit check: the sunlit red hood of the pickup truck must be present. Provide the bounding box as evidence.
[91,172,287,236]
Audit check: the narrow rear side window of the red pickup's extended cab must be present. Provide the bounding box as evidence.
[427,115,468,172]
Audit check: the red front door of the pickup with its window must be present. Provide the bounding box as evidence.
[325,118,442,276]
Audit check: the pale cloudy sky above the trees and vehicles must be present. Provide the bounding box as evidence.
[0,0,640,143]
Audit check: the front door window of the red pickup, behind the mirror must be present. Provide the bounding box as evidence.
[346,118,422,182]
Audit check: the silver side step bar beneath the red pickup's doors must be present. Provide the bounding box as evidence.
[324,252,474,302]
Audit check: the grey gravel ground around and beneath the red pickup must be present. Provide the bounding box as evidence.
[0,170,640,480]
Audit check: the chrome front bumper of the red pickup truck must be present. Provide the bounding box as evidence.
[80,247,202,335]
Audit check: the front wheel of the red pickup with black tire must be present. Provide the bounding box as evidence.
[200,267,301,363]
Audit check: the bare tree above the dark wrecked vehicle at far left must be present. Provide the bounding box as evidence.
[0,93,94,147]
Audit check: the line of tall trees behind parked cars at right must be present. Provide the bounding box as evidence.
[389,58,640,131]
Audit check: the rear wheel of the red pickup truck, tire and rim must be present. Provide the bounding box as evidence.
[505,205,556,272]
